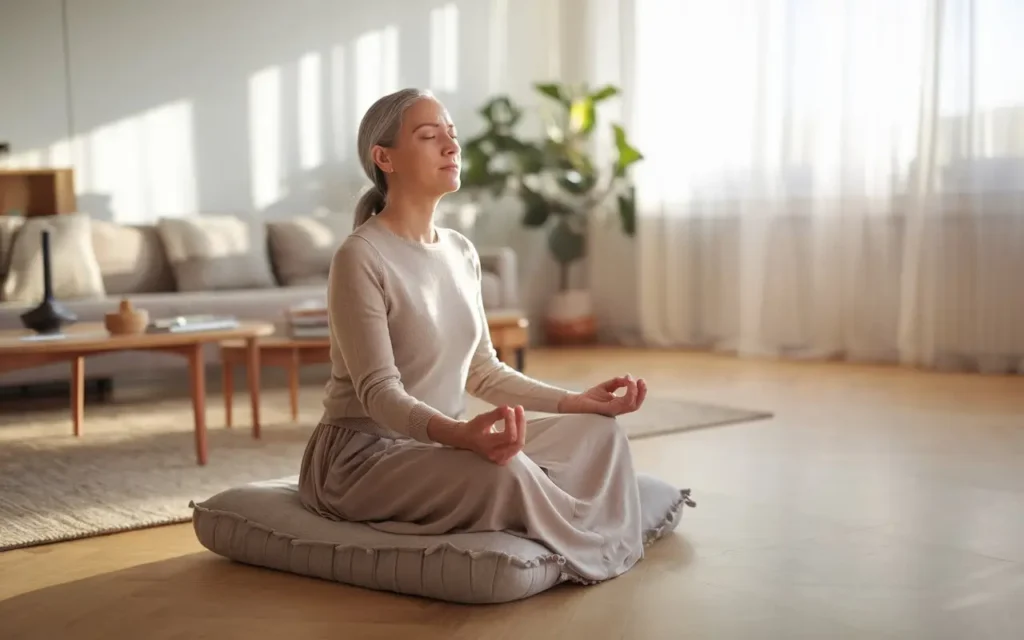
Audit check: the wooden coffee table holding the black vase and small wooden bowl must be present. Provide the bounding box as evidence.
[0,323,273,465]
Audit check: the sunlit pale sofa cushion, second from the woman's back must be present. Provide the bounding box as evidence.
[157,214,276,292]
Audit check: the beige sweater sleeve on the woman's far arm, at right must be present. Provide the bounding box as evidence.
[466,249,571,414]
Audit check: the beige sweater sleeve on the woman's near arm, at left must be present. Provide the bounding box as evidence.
[328,238,443,442]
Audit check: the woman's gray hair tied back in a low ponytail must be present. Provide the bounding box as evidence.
[352,89,433,230]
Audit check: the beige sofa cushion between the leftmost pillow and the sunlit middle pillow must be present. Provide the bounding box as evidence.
[92,219,174,295]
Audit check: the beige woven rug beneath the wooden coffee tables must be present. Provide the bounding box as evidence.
[0,378,770,550]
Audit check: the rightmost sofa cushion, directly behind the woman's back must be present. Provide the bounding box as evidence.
[266,213,352,286]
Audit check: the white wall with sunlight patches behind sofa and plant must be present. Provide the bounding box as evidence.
[0,0,629,339]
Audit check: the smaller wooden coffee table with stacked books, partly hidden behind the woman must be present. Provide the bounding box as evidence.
[220,311,529,426]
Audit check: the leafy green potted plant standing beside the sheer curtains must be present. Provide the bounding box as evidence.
[462,83,643,343]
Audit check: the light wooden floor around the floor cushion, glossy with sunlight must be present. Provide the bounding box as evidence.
[0,349,1024,640]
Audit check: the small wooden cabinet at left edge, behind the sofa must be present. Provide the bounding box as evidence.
[0,169,78,216]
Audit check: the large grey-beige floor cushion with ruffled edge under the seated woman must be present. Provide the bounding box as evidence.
[190,475,692,603]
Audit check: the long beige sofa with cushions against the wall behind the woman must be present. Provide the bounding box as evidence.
[0,213,517,387]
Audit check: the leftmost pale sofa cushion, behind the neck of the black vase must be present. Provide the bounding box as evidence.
[3,213,105,303]
